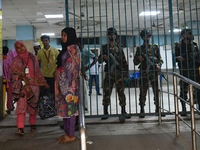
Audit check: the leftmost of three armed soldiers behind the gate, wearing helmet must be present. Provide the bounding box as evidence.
[99,28,131,122]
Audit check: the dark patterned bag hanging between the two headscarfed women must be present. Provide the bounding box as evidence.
[38,87,56,119]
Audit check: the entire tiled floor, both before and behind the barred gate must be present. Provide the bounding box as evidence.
[0,84,200,150]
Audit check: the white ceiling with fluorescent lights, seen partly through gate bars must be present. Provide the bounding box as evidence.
[2,0,200,40]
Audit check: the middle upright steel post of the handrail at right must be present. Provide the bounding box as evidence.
[173,76,180,135]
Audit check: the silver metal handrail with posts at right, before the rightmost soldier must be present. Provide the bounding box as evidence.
[159,72,200,150]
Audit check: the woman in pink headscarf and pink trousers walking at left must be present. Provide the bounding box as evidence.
[10,41,48,136]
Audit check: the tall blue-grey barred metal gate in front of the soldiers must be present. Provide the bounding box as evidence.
[66,0,200,117]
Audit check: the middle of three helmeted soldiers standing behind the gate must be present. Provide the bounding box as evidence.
[133,29,163,118]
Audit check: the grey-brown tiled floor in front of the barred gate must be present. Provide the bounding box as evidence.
[0,115,200,150]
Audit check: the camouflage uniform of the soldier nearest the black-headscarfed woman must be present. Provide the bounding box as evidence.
[99,43,128,106]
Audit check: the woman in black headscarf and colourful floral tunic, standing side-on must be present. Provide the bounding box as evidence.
[55,27,80,143]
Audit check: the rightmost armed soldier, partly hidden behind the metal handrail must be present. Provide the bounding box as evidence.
[175,29,200,116]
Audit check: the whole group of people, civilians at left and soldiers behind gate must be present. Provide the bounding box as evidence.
[3,27,200,143]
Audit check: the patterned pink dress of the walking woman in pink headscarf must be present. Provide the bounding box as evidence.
[10,53,46,114]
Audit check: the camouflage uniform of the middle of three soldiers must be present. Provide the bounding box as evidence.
[133,44,163,112]
